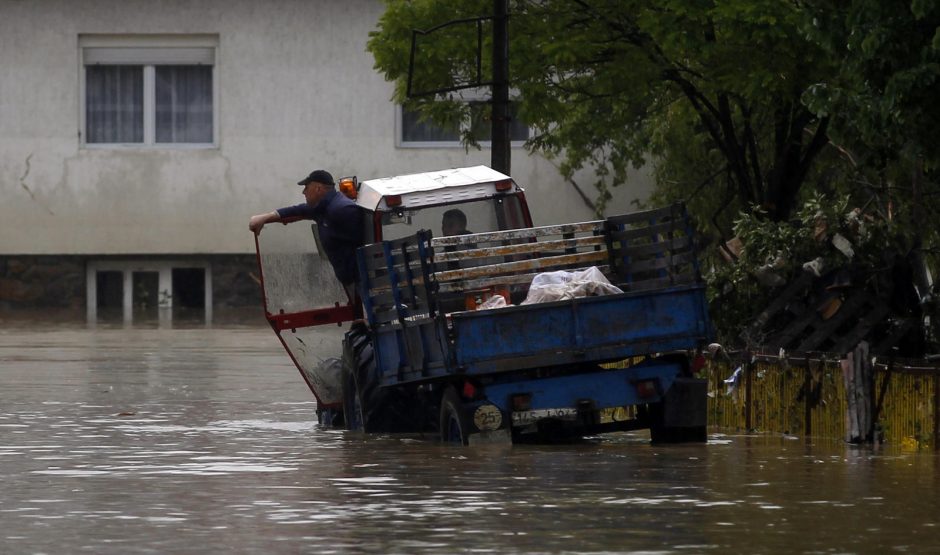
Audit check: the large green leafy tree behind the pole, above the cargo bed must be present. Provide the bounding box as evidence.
[368,0,832,228]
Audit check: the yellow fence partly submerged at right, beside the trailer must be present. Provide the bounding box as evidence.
[703,353,940,449]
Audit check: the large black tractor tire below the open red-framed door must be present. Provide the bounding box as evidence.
[343,322,413,433]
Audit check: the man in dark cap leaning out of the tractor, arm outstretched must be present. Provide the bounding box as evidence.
[248,170,363,302]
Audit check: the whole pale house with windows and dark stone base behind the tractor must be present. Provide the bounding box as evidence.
[0,0,645,320]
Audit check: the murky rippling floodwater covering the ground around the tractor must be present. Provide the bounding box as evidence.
[0,323,940,554]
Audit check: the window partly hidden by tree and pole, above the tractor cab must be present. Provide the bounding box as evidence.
[399,101,529,147]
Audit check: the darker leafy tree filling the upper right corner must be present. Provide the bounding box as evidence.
[805,0,940,252]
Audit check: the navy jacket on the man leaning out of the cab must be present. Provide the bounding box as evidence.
[277,191,363,284]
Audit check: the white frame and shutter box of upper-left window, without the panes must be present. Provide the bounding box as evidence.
[78,35,219,150]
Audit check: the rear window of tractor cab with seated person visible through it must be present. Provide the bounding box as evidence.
[382,195,526,240]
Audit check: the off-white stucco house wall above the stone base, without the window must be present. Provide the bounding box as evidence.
[0,0,648,255]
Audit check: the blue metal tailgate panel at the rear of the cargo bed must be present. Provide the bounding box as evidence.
[451,286,706,374]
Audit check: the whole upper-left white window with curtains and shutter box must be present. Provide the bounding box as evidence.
[82,37,216,146]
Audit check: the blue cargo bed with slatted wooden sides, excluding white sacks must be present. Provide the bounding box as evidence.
[358,205,710,385]
